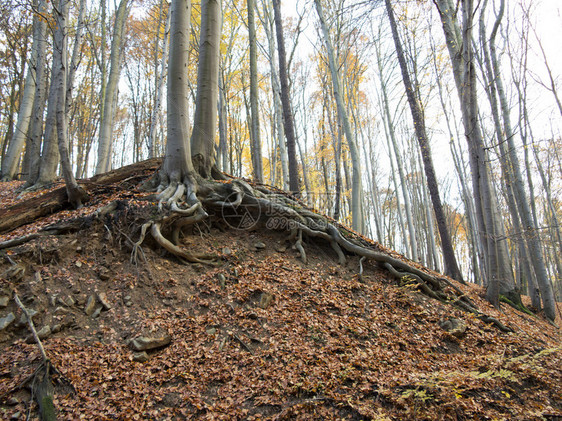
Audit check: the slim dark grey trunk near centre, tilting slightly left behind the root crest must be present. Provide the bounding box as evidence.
[273,0,300,195]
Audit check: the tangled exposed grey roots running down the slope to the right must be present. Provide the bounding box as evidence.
[132,172,511,332]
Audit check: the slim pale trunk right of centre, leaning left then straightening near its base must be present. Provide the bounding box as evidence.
[314,0,364,232]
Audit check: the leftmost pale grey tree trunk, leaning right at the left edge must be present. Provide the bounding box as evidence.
[0,0,40,181]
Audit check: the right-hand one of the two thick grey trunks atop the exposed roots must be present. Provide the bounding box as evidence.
[191,0,222,177]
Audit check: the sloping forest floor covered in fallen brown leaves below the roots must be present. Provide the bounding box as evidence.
[0,171,562,420]
